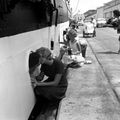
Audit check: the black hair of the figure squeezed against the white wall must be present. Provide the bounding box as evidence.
[29,51,40,73]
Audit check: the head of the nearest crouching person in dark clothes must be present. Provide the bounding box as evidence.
[36,47,52,64]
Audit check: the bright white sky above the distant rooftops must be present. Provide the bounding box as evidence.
[70,0,112,14]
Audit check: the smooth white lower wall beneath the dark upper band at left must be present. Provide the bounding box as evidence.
[0,25,59,120]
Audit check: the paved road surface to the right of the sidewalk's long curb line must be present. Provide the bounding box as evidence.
[87,28,120,99]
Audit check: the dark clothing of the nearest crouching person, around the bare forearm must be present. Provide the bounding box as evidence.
[35,59,68,100]
